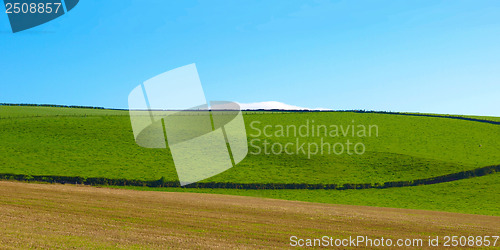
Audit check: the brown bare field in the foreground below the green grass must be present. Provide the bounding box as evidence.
[0,181,500,248]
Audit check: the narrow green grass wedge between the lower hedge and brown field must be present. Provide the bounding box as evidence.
[114,173,500,216]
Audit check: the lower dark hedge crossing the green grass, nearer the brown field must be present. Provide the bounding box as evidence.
[0,165,500,190]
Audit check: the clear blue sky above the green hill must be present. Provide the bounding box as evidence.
[0,0,500,116]
